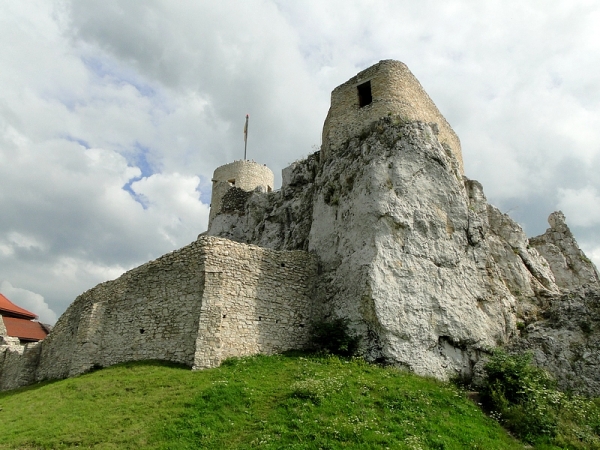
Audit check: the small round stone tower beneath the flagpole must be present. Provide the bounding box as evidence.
[208,160,275,228]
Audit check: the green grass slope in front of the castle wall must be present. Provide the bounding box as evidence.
[0,354,523,450]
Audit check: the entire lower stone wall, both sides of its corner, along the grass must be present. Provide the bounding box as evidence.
[0,236,317,390]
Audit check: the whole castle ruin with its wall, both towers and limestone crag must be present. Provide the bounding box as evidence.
[0,61,600,392]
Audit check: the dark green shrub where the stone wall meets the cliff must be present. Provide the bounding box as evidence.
[311,319,360,357]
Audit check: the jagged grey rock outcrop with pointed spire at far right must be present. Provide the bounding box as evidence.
[529,211,600,289]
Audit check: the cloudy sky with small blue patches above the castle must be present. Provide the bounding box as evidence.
[0,0,600,323]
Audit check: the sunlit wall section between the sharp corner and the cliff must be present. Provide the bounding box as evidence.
[194,237,317,368]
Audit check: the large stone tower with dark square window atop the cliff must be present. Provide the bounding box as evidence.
[321,59,464,173]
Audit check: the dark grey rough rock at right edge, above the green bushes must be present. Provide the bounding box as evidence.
[510,287,600,396]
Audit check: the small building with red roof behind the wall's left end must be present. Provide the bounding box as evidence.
[0,294,49,344]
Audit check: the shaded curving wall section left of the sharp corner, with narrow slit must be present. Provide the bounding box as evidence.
[36,241,210,380]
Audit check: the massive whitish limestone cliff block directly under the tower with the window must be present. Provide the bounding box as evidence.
[309,121,526,379]
